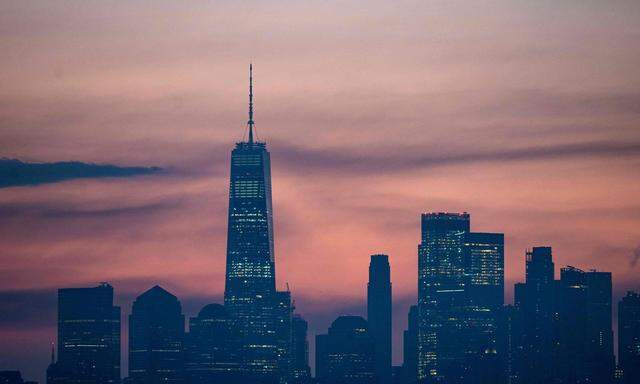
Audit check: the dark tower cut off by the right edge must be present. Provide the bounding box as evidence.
[618,292,640,384]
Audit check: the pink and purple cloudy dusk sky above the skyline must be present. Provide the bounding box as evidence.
[0,0,640,381]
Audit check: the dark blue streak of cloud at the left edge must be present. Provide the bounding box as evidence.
[0,159,162,188]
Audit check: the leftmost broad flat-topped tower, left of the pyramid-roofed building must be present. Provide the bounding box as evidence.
[47,283,120,384]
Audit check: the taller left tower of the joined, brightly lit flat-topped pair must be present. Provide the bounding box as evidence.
[418,213,470,382]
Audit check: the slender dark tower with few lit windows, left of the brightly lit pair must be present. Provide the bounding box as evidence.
[367,255,391,384]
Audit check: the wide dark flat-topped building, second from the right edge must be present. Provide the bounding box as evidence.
[555,267,615,384]
